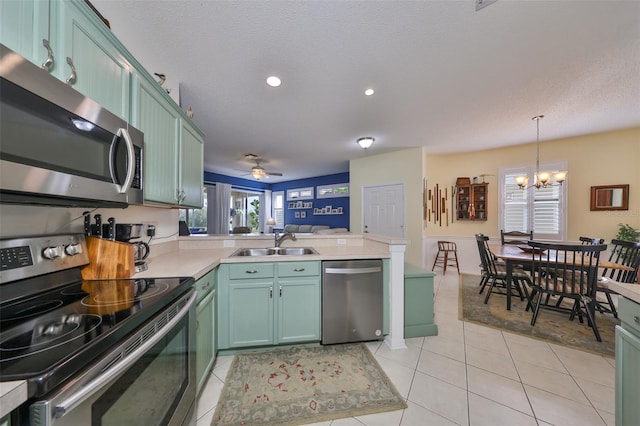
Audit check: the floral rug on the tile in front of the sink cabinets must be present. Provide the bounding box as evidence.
[211,343,407,426]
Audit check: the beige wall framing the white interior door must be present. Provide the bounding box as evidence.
[349,147,425,265]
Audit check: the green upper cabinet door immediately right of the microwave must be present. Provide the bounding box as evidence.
[132,76,180,205]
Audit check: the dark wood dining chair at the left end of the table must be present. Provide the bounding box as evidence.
[476,234,529,304]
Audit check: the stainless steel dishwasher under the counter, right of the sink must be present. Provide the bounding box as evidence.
[322,259,383,344]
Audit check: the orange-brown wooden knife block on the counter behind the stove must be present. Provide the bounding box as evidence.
[81,237,136,280]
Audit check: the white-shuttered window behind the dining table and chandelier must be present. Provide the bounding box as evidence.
[498,162,567,241]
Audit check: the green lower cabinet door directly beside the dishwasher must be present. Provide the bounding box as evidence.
[277,277,321,343]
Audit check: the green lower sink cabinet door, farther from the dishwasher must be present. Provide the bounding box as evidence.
[228,280,274,348]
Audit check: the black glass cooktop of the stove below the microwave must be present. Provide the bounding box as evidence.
[0,278,193,396]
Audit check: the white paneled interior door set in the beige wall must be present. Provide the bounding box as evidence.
[362,184,405,238]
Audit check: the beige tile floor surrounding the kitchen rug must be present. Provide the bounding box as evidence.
[197,273,615,426]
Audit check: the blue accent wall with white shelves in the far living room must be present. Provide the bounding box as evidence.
[204,172,350,229]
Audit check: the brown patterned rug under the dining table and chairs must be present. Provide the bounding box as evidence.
[458,274,620,358]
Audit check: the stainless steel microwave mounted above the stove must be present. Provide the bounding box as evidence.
[0,44,144,207]
